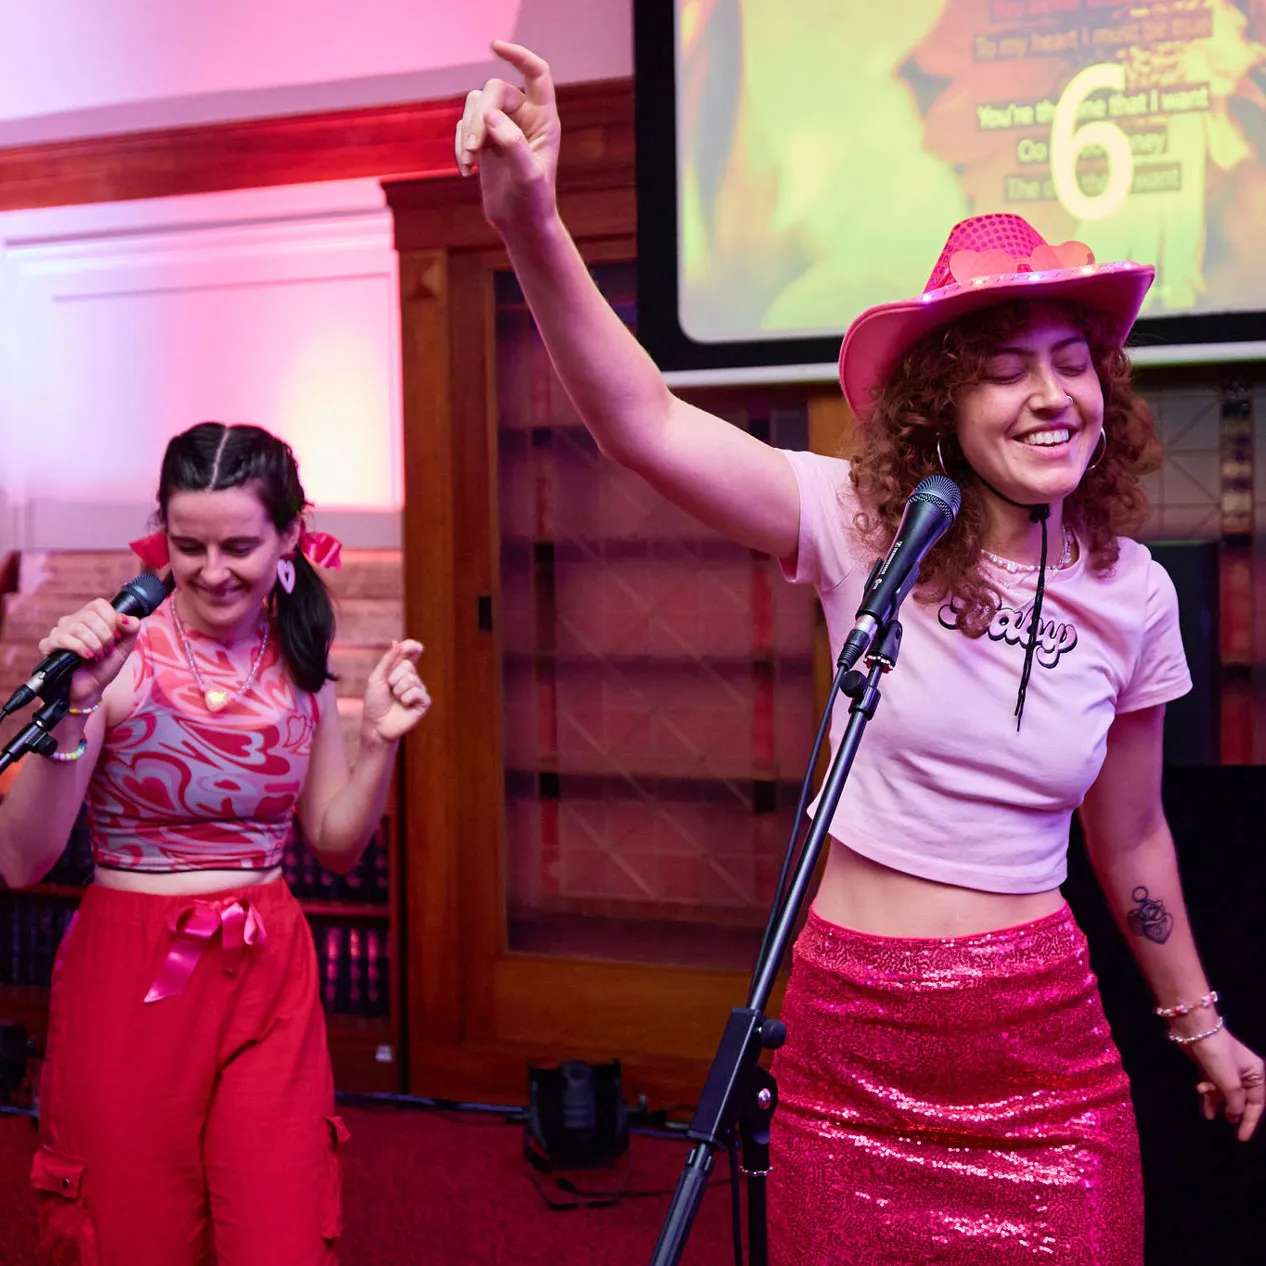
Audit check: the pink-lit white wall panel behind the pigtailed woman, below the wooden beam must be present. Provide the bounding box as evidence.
[0,180,403,552]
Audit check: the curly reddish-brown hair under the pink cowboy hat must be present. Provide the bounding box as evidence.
[851,301,1160,637]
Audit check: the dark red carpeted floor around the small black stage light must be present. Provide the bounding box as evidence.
[0,1106,733,1266]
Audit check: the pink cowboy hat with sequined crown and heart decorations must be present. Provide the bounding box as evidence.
[839,214,1156,420]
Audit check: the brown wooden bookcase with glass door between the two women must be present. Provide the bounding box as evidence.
[385,85,848,1104]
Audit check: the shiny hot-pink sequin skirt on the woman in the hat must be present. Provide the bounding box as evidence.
[770,906,1143,1266]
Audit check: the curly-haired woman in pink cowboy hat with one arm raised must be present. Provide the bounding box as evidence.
[456,44,1263,1266]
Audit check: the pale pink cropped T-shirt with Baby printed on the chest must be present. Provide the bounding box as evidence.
[784,452,1191,893]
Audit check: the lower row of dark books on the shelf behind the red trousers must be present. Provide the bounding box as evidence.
[0,893,391,1015]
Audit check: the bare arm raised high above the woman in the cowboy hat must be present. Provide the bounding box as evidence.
[456,42,800,558]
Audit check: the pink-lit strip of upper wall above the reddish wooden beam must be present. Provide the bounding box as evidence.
[0,0,633,144]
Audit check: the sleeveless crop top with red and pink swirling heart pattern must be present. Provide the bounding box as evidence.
[87,601,318,872]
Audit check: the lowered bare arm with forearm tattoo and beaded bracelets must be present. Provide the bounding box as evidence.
[1081,704,1266,1139]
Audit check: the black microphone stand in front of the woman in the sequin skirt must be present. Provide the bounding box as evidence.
[651,614,901,1266]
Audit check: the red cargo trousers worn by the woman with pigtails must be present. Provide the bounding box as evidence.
[32,880,346,1266]
